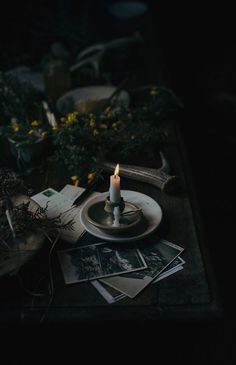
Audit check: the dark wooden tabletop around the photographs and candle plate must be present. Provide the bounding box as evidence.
[0,124,222,323]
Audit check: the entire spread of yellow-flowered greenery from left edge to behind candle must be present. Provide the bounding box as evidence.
[0,75,182,182]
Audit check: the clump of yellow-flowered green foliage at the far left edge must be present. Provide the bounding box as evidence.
[0,74,51,145]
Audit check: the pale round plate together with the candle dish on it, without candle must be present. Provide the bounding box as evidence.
[80,190,162,243]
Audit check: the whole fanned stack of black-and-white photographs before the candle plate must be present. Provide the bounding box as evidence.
[58,240,185,304]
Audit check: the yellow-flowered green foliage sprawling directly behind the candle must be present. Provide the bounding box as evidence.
[53,87,181,179]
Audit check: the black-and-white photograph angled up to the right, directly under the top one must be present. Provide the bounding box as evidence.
[101,240,184,298]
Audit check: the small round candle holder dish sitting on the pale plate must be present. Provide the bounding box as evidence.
[84,196,143,234]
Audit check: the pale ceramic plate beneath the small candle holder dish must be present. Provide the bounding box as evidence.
[80,190,162,242]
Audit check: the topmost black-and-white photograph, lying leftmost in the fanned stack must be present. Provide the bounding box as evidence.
[58,243,147,284]
